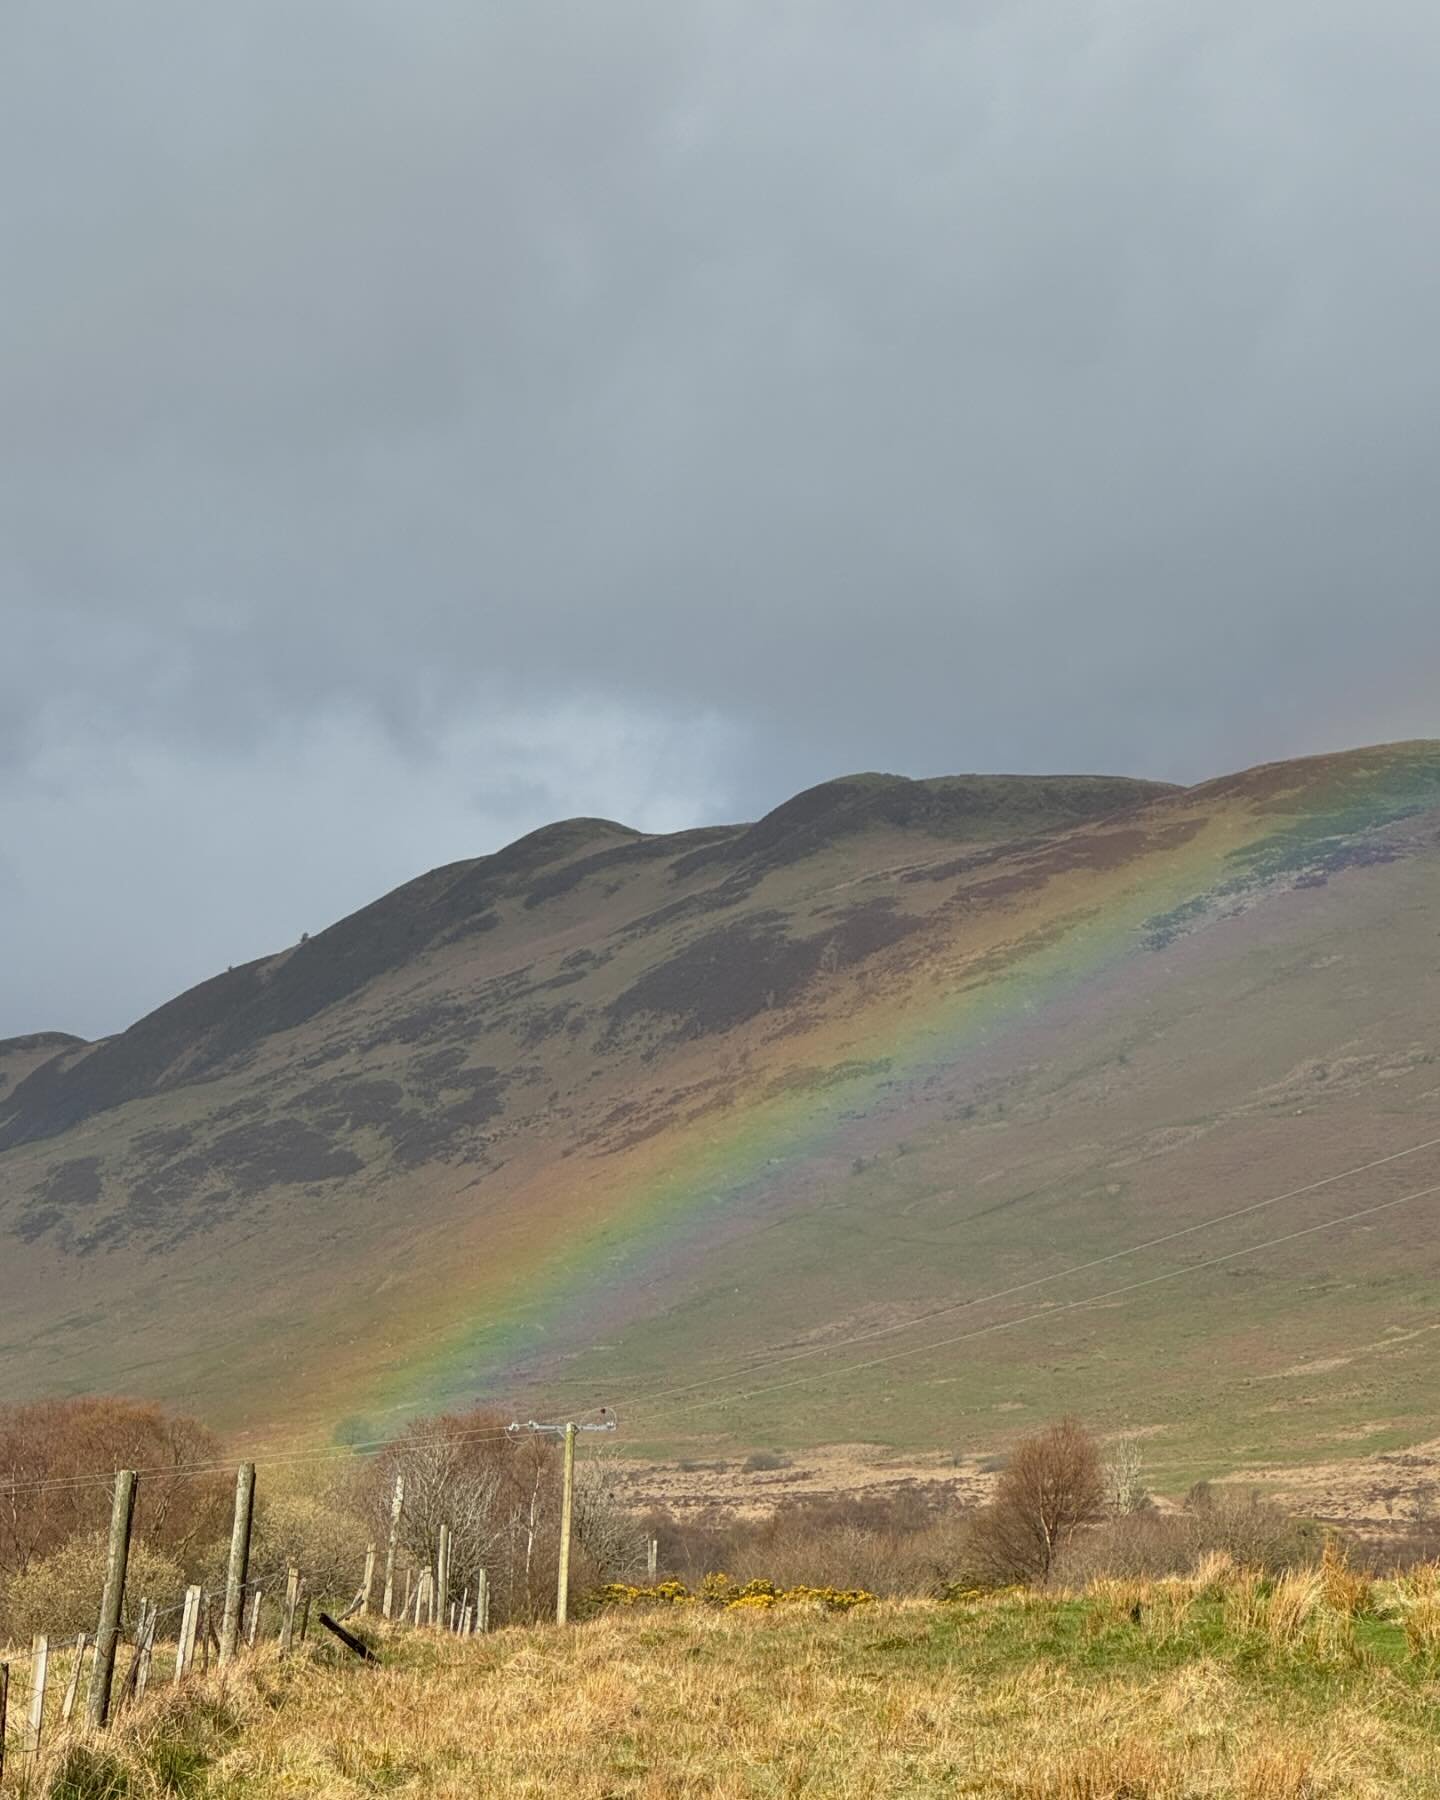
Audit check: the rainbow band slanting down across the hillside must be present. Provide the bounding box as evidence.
[329,743,1440,1426]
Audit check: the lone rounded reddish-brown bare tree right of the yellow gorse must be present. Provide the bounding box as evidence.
[970,1418,1105,1582]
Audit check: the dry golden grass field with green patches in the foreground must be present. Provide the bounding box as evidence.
[13,1573,1440,1800]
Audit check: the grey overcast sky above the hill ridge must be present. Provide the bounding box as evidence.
[0,0,1440,1037]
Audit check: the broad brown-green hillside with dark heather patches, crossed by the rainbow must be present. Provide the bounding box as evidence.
[0,743,1440,1480]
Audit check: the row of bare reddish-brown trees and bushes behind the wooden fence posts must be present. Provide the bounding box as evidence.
[0,1397,644,1642]
